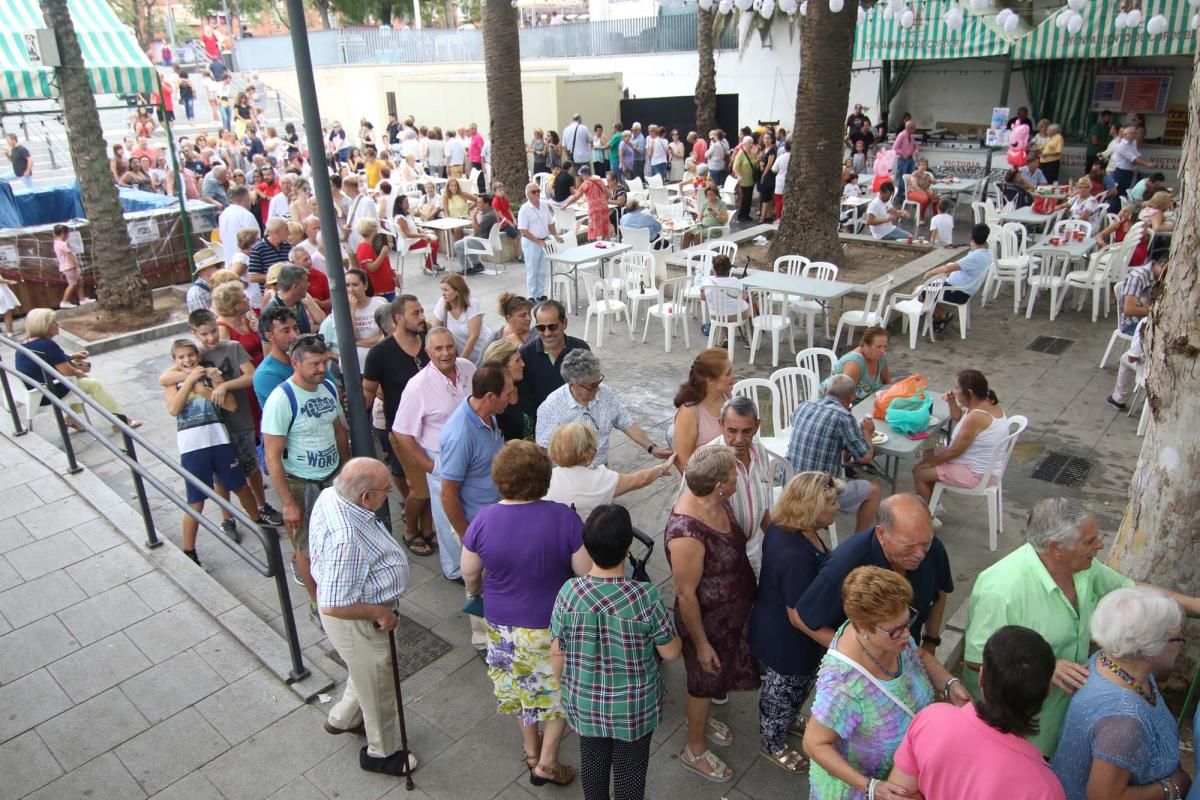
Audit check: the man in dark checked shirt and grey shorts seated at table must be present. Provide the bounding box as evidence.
[787,374,880,532]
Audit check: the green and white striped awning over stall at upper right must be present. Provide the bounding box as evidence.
[854,0,1196,61]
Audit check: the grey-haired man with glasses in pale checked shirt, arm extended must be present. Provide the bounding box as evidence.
[535,350,671,467]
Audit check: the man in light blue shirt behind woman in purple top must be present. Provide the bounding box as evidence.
[436,366,512,652]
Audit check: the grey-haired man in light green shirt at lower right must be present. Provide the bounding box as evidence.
[962,498,1200,757]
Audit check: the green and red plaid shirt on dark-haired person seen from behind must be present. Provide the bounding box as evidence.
[550,576,674,741]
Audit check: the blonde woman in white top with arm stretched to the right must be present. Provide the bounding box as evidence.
[546,422,676,521]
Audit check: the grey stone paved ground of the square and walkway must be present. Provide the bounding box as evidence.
[0,227,1140,800]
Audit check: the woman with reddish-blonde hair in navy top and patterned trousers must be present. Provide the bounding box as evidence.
[750,473,842,772]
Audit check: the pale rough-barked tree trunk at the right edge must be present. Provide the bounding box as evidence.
[1109,47,1200,642]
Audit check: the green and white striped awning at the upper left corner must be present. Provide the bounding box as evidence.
[0,0,158,100]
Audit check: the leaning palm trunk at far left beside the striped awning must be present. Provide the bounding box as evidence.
[41,0,152,325]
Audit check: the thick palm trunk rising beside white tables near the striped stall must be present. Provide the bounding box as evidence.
[770,2,858,264]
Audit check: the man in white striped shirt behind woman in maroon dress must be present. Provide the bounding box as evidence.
[706,397,773,577]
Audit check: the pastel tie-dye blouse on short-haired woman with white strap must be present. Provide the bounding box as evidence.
[809,622,934,800]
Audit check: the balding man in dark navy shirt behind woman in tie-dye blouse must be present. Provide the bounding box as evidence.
[796,494,954,650]
